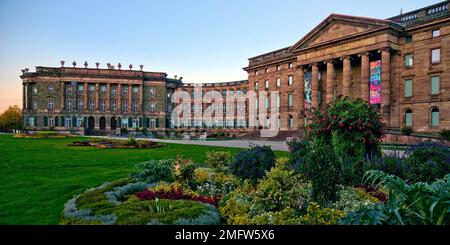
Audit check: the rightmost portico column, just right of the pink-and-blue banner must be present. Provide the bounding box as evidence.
[381,49,391,127]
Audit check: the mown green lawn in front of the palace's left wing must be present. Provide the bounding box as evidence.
[0,135,287,224]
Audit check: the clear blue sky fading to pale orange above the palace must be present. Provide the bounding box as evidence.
[0,0,441,112]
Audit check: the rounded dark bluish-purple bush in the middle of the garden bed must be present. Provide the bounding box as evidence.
[230,146,275,183]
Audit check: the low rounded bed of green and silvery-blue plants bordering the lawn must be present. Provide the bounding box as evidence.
[60,179,220,225]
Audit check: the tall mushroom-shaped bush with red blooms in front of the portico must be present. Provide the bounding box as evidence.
[308,98,385,185]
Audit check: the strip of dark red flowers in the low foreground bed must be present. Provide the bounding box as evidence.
[136,185,219,206]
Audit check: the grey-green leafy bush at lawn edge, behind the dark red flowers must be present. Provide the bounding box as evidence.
[131,159,174,183]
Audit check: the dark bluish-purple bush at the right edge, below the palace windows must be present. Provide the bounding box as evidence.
[404,142,450,182]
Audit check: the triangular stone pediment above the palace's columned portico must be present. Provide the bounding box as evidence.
[290,14,396,51]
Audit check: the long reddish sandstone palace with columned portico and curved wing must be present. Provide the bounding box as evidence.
[21,1,450,134]
